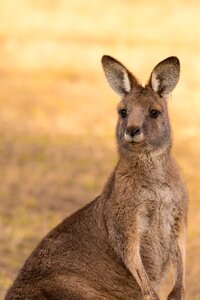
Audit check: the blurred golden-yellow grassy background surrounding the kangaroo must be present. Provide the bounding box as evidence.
[0,0,200,300]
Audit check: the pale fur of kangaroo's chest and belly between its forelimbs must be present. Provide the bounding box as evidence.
[138,184,176,280]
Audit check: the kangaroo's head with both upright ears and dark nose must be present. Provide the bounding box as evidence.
[102,55,180,154]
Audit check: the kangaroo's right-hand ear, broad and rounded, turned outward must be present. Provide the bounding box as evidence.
[149,56,180,98]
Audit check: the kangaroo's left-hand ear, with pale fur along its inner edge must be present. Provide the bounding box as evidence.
[102,55,138,96]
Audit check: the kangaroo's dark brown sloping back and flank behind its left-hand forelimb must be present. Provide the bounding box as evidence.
[6,198,140,300]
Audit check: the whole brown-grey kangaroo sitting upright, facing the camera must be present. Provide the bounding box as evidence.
[5,55,188,300]
